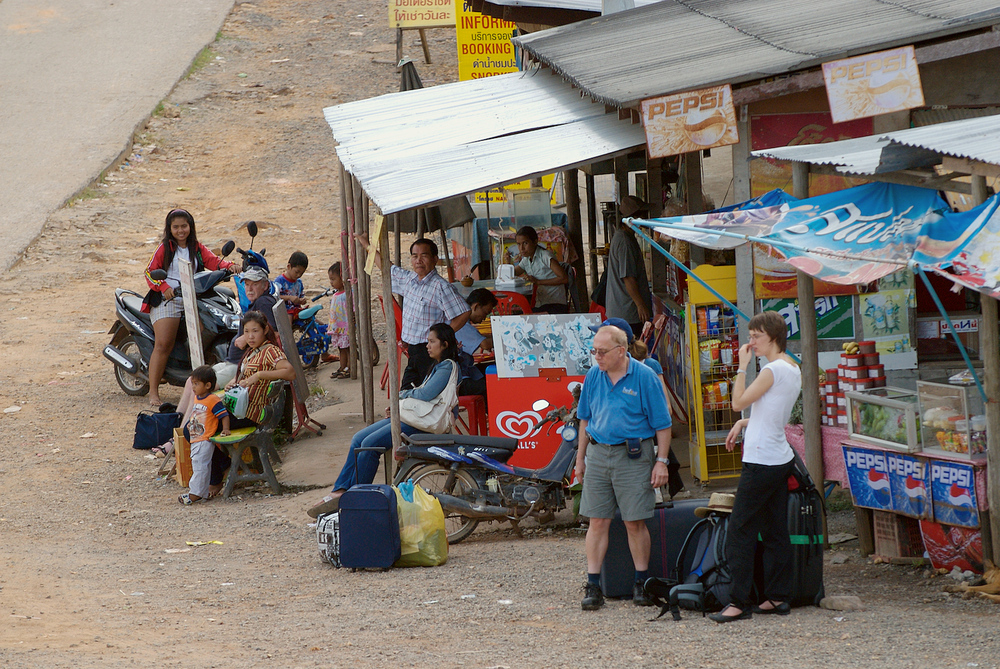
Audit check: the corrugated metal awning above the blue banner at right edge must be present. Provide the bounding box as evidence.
[753,115,1000,174]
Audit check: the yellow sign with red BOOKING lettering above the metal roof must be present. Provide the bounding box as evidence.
[455,0,517,81]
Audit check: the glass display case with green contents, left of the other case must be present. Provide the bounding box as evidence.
[845,387,922,453]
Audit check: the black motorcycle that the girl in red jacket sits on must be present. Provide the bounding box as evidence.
[103,241,242,395]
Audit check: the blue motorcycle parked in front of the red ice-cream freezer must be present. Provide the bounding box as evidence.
[393,387,580,544]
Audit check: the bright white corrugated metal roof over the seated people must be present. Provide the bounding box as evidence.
[323,73,646,214]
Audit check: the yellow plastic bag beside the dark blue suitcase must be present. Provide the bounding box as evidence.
[393,483,448,567]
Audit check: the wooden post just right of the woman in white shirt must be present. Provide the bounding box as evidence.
[792,163,824,494]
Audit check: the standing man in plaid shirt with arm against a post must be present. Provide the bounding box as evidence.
[358,236,469,390]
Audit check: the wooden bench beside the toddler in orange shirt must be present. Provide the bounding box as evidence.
[212,381,288,497]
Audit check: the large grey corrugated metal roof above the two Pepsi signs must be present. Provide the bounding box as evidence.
[514,0,1000,107]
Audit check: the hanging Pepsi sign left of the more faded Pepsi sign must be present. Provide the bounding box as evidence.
[641,84,740,158]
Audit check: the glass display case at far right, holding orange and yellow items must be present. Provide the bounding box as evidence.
[917,381,986,460]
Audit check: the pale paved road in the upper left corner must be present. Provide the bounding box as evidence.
[0,0,233,272]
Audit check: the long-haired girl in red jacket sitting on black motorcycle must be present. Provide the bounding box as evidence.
[143,209,233,406]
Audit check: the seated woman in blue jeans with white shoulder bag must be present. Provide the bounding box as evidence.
[308,323,461,518]
